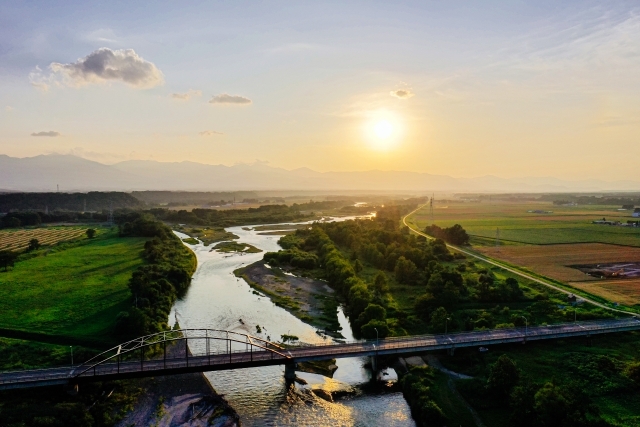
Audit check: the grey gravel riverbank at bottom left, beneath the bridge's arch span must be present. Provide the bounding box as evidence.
[116,345,241,427]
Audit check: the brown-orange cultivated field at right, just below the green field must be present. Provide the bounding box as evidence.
[476,243,640,282]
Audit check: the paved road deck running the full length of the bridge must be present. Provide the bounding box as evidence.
[0,317,640,390]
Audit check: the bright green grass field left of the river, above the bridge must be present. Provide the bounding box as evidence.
[0,233,146,344]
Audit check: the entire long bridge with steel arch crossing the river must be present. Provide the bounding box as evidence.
[0,317,640,390]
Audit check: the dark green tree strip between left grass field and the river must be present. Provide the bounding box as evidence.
[116,214,196,336]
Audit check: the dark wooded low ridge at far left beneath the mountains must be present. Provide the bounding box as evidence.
[0,191,144,212]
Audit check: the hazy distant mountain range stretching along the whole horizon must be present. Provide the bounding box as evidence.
[0,154,640,193]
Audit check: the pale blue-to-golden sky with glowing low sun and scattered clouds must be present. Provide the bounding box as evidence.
[0,0,640,180]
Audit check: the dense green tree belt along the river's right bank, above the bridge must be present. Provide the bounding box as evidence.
[265,206,452,339]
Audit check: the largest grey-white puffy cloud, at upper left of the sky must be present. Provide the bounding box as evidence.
[36,47,164,90]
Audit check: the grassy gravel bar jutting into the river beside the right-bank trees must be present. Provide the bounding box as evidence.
[234,261,343,338]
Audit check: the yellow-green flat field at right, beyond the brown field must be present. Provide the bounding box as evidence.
[408,202,640,246]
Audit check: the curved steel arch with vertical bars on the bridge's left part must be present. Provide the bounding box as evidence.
[71,328,292,379]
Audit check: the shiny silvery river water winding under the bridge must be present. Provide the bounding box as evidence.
[175,218,415,427]
